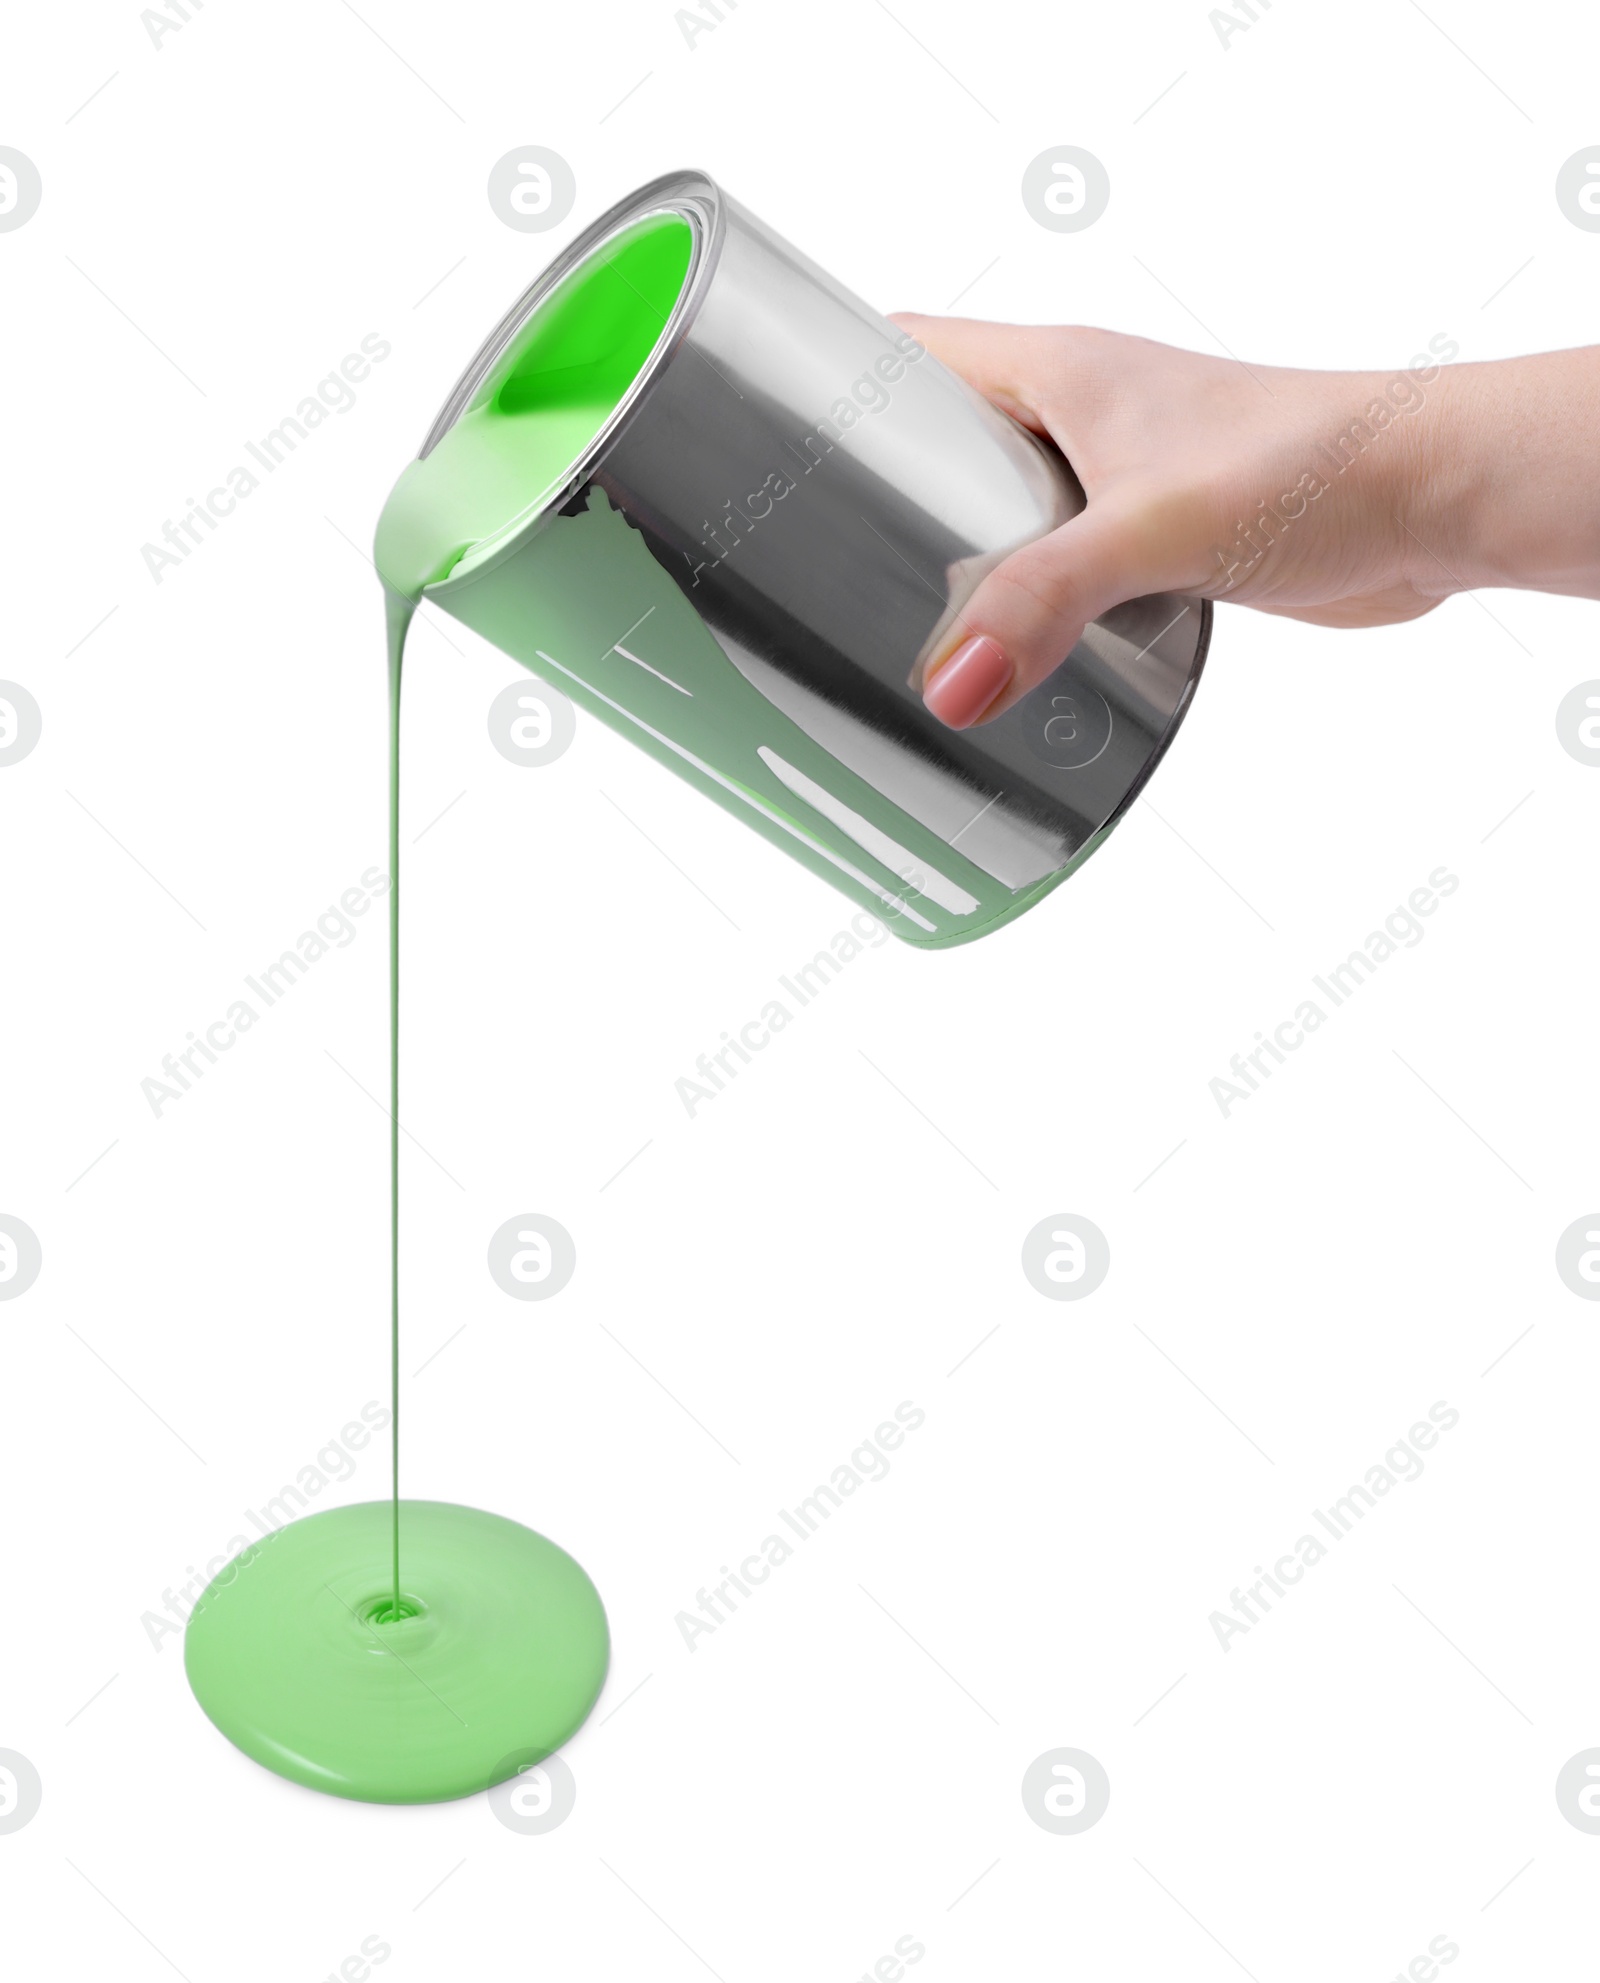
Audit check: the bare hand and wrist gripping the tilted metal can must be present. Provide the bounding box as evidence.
[894,315,1600,728]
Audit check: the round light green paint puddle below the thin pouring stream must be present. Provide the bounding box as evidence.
[184,1501,609,1805]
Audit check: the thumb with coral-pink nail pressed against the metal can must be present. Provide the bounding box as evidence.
[922,496,1152,730]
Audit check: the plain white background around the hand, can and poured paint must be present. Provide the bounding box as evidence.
[0,0,1600,1983]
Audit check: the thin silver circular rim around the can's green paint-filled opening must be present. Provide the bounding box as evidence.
[418,169,726,599]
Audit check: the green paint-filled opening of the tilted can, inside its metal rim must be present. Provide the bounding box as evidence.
[373,212,694,599]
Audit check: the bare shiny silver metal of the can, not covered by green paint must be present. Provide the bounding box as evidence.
[432,173,1211,890]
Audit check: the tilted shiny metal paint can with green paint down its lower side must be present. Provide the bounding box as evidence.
[390,173,1211,948]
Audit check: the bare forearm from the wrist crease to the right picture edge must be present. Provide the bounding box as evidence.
[1396,347,1600,599]
